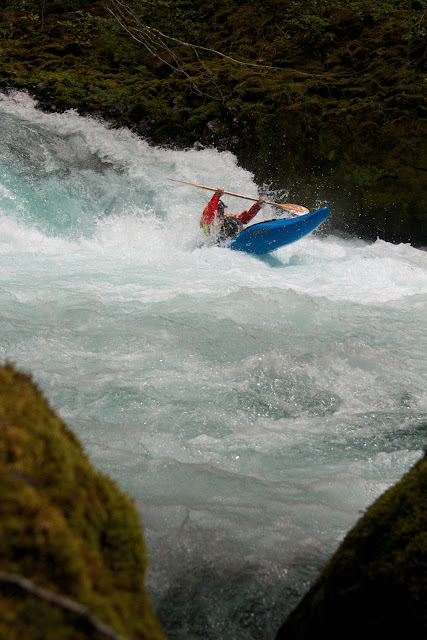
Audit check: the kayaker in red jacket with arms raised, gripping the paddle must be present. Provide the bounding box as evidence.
[200,189,265,242]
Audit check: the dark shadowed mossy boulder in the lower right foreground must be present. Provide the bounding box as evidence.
[276,456,427,640]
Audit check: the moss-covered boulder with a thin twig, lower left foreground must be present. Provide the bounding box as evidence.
[0,365,164,640]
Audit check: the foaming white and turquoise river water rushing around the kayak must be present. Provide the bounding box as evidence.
[0,94,427,640]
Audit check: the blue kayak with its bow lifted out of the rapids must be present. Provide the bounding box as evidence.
[219,207,329,254]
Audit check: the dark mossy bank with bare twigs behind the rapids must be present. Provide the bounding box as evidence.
[0,0,427,244]
